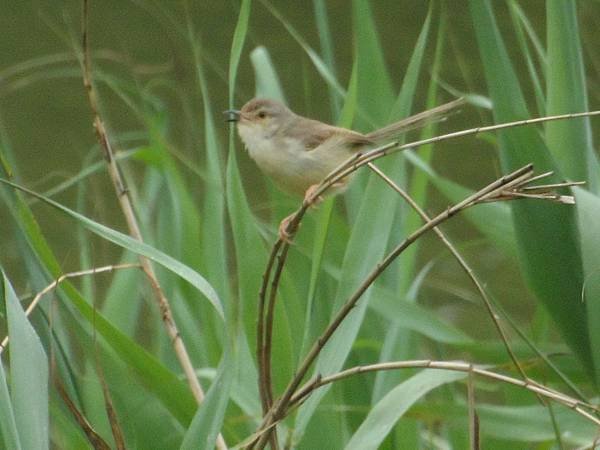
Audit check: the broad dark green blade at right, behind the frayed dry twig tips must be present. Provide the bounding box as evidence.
[470,0,592,371]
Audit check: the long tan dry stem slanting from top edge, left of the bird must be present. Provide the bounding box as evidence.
[81,4,227,450]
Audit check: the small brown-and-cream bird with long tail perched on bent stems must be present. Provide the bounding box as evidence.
[225,98,464,240]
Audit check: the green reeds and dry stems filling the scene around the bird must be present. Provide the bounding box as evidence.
[0,0,600,450]
